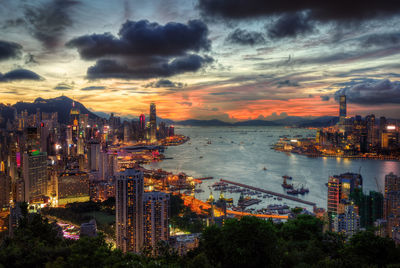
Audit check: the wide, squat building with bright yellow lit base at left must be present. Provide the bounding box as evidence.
[57,171,90,205]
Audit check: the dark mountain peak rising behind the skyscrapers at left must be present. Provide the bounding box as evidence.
[13,96,98,124]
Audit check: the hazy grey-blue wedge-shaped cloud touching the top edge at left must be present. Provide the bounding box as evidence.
[24,0,80,49]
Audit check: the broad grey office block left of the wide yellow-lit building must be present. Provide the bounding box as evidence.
[23,150,47,202]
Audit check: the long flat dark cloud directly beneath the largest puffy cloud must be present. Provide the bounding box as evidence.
[87,54,213,79]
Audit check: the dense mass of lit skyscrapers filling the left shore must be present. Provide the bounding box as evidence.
[0,97,187,252]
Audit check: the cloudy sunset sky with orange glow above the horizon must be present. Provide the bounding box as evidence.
[0,0,400,121]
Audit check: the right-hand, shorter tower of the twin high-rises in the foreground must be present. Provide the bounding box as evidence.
[143,192,169,250]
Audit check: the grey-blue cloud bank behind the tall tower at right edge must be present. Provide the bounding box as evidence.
[335,79,400,105]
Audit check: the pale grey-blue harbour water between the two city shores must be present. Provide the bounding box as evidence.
[146,126,400,208]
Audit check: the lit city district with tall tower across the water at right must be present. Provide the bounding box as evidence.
[276,95,400,160]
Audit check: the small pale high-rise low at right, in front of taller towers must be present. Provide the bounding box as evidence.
[334,205,360,237]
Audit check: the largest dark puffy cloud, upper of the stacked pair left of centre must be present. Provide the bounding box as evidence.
[67,20,211,59]
